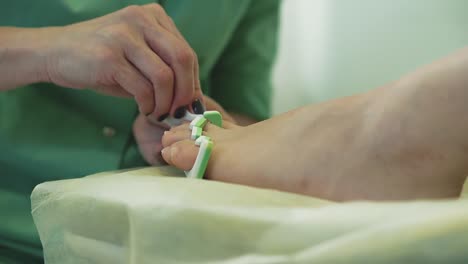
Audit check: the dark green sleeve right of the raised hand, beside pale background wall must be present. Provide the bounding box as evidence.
[211,0,280,120]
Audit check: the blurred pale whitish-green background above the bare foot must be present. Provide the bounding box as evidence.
[273,0,468,114]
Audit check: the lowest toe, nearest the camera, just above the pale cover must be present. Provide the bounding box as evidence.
[161,140,199,171]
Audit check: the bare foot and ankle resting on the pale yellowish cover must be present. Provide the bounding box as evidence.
[163,49,468,200]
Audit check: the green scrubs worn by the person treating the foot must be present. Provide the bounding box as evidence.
[0,0,279,263]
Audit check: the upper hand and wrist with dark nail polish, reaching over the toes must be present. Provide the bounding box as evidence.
[45,4,202,120]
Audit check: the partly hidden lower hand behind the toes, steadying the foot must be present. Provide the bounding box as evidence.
[133,96,235,165]
